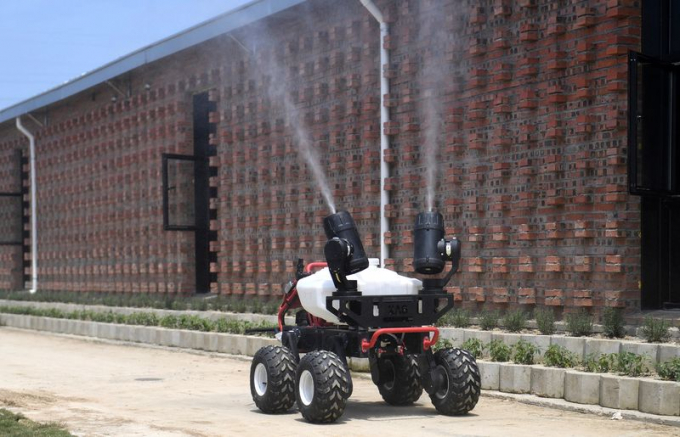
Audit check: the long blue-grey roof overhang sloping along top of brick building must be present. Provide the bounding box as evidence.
[0,0,306,123]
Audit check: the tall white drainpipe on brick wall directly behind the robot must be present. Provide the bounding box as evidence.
[361,0,390,267]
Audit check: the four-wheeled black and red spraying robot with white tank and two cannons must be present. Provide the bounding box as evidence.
[250,211,480,423]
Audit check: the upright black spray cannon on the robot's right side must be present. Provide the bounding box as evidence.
[413,211,460,293]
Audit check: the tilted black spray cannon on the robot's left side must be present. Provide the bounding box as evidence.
[323,211,368,294]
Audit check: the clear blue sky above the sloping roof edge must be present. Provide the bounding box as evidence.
[0,0,252,109]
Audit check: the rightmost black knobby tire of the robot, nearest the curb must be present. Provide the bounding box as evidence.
[430,348,481,416]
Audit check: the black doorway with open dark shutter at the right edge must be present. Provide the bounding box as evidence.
[628,0,680,309]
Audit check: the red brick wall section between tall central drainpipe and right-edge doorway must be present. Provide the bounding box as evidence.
[389,0,640,309]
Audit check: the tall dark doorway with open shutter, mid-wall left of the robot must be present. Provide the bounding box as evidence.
[163,92,215,293]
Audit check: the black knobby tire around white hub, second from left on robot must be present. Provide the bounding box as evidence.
[295,350,352,423]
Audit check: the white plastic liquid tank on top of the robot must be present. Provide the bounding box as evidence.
[297,258,423,324]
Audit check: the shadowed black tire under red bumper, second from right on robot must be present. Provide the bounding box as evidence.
[378,355,423,406]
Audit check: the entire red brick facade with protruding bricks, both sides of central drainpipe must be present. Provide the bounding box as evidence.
[0,0,640,309]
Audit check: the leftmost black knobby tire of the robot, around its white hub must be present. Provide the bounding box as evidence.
[250,345,297,414]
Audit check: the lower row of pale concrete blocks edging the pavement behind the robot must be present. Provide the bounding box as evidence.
[0,314,680,418]
